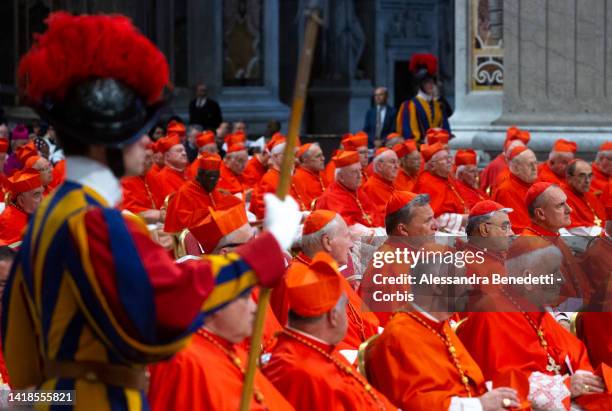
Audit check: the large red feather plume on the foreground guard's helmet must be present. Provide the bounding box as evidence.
[18,12,169,104]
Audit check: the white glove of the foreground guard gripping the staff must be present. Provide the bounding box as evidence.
[264,193,302,250]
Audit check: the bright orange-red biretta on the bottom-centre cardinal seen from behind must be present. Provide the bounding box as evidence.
[285,252,342,317]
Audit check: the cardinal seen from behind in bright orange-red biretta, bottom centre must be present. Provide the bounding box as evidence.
[262,253,395,410]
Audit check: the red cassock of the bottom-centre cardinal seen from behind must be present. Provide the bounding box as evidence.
[262,330,396,411]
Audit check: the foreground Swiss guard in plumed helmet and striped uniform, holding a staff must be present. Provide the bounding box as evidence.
[1,12,300,410]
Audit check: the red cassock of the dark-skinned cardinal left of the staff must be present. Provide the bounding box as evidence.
[164,180,242,233]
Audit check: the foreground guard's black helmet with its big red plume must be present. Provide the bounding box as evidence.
[18,12,169,151]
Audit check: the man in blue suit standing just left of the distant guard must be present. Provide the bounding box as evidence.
[363,87,397,148]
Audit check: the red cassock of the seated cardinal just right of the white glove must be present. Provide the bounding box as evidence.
[315,181,385,227]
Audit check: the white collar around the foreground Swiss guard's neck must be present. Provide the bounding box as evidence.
[66,156,121,207]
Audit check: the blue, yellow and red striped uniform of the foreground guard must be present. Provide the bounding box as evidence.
[2,181,284,411]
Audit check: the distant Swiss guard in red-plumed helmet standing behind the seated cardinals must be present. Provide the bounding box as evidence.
[397,54,450,144]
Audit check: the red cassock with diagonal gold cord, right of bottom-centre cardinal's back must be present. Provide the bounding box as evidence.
[366,312,486,411]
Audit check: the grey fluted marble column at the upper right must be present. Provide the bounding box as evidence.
[495,0,612,154]
